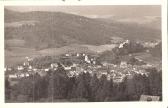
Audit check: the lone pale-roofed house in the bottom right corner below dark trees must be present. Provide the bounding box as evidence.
[140,95,160,101]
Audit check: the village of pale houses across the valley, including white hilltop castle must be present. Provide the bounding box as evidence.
[5,40,160,83]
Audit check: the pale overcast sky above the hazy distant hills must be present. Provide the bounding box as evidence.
[5,5,161,18]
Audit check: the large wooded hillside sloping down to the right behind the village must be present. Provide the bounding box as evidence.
[5,9,161,49]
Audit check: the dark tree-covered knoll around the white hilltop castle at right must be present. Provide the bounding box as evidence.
[99,41,162,65]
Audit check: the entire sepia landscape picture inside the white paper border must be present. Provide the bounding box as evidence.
[4,5,162,103]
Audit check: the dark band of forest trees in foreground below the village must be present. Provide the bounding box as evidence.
[5,66,162,102]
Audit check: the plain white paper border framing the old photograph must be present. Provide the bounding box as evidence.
[0,0,168,108]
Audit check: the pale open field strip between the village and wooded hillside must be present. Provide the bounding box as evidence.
[5,45,98,66]
